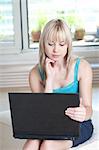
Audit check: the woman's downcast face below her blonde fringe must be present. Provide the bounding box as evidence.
[45,40,67,61]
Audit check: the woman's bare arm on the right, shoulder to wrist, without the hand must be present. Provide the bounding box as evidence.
[79,60,92,120]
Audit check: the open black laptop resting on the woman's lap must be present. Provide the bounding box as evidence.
[9,93,79,140]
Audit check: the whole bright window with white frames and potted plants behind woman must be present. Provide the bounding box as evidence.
[0,0,99,57]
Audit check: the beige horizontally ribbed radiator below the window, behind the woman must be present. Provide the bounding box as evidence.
[0,64,99,89]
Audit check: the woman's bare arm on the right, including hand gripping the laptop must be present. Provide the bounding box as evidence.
[66,60,92,122]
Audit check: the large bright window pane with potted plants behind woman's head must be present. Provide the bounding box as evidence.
[27,0,99,48]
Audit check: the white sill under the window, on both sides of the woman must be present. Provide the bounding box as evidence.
[0,46,99,65]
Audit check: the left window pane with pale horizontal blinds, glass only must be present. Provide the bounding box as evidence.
[0,0,15,45]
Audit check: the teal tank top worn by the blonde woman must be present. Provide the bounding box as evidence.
[38,58,80,93]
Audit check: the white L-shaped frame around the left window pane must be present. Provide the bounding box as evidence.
[0,0,22,54]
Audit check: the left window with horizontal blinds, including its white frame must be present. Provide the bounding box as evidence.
[0,0,21,54]
